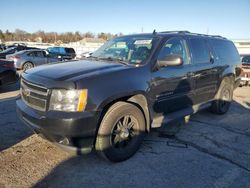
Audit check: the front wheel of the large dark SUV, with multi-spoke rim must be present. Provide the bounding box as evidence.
[95,102,145,162]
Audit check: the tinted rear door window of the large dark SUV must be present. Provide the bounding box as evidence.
[190,38,210,63]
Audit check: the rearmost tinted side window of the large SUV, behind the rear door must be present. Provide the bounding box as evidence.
[211,39,240,61]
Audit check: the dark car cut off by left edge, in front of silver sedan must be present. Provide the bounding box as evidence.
[0,59,19,86]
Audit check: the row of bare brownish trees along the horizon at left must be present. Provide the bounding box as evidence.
[0,29,122,43]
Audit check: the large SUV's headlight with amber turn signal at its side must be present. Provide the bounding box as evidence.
[49,89,88,112]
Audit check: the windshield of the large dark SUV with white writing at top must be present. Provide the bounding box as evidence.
[90,36,155,64]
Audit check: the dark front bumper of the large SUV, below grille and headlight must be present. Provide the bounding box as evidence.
[16,99,100,154]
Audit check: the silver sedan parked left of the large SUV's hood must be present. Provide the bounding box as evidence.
[6,49,61,70]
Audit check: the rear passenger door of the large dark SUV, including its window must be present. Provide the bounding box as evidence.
[188,37,219,104]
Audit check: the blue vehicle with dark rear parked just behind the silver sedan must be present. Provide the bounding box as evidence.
[47,47,76,60]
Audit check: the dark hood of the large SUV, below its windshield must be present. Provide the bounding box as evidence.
[27,60,128,81]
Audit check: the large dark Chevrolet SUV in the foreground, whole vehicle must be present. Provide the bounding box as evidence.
[16,31,241,161]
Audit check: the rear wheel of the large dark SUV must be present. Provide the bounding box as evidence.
[211,79,234,114]
